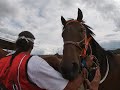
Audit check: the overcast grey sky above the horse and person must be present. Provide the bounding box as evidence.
[0,0,120,54]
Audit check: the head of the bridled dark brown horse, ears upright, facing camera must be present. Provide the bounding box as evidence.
[61,9,89,80]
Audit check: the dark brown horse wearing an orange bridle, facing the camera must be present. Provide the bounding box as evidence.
[60,9,120,90]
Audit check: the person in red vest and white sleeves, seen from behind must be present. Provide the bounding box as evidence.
[0,31,101,90]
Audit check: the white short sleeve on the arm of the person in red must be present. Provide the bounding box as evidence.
[27,56,68,90]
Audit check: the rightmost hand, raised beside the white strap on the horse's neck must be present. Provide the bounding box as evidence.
[85,67,101,90]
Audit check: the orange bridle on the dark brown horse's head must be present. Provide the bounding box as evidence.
[63,20,99,77]
